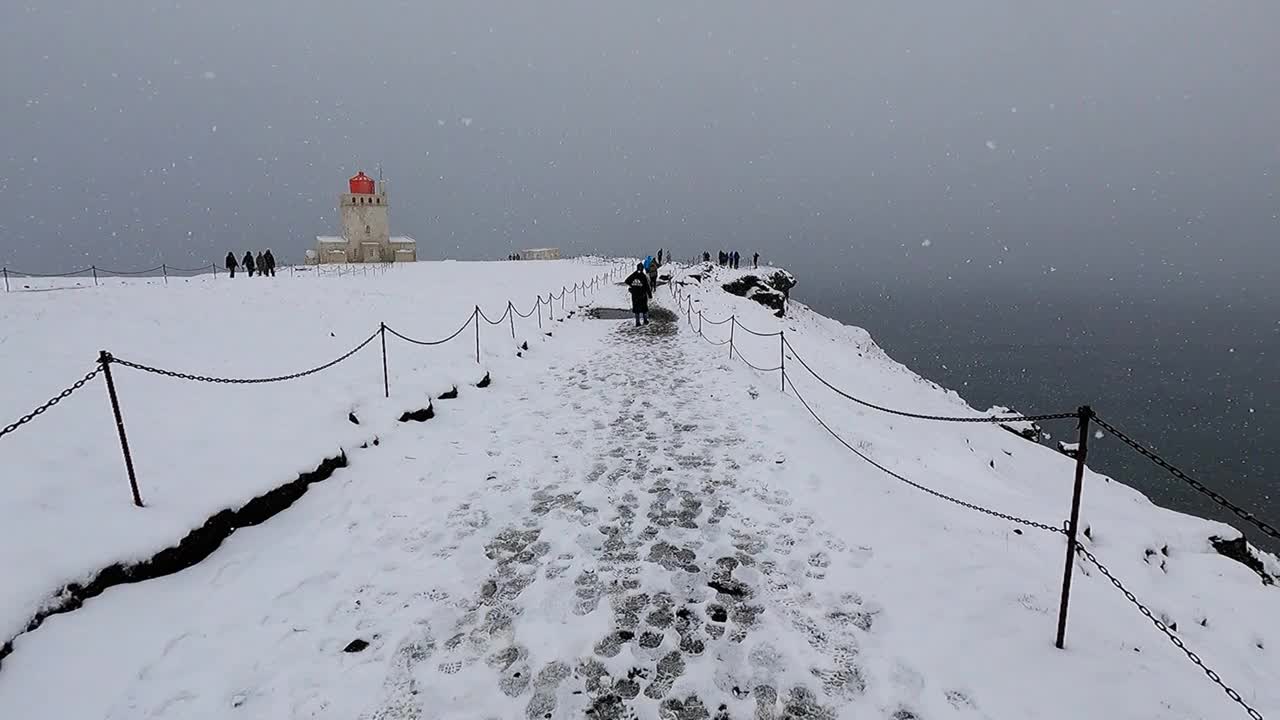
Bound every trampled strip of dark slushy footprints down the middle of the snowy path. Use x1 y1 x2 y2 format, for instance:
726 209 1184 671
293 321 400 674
365 307 919 720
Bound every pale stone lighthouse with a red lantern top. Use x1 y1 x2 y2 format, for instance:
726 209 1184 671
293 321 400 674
316 172 417 263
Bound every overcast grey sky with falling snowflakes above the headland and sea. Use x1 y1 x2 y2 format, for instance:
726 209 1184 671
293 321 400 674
0 0 1280 292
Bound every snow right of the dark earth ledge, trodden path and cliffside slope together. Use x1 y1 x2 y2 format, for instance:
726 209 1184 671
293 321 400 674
0 265 1280 720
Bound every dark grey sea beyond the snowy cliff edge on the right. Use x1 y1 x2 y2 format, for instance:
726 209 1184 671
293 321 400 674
794 273 1280 552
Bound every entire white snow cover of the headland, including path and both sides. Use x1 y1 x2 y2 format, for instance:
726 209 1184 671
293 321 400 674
0 261 1280 720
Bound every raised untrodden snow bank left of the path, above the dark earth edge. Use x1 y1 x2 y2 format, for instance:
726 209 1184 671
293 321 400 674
0 260 612 643
